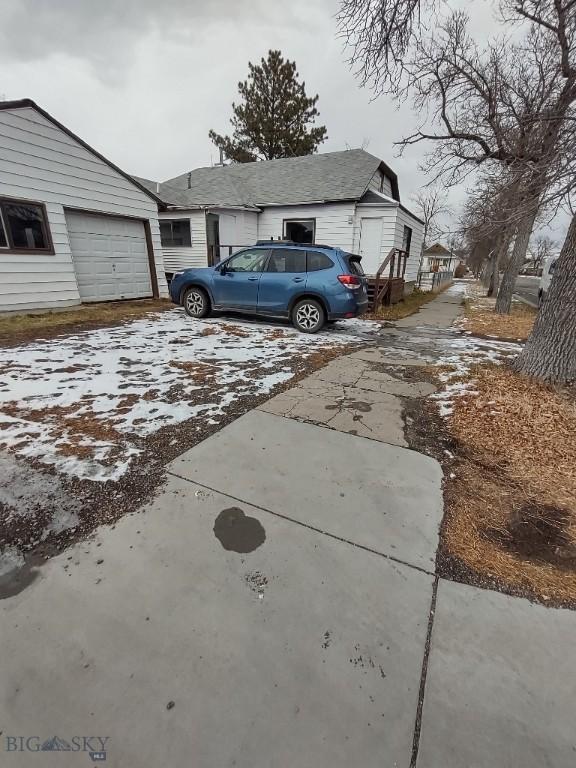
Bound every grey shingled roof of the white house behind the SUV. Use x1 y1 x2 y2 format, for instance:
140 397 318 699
139 149 400 208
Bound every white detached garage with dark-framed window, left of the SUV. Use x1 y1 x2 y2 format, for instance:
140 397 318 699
0 99 167 311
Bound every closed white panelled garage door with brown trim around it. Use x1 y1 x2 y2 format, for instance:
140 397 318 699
66 211 152 301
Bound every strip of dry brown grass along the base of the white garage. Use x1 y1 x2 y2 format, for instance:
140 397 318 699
0 299 174 341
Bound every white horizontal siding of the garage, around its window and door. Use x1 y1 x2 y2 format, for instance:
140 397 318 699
0 107 167 311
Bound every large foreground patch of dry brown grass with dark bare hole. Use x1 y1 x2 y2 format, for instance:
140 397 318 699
443 366 576 603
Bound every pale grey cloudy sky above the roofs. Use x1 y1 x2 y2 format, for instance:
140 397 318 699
0 0 568 242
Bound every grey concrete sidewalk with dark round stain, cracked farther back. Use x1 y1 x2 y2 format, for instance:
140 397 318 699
0 284 576 768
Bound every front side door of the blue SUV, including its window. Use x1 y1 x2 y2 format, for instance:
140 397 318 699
212 248 269 311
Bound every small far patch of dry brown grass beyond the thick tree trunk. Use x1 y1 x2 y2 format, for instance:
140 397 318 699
460 298 536 341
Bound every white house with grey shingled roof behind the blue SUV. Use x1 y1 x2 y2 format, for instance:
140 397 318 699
135 149 423 283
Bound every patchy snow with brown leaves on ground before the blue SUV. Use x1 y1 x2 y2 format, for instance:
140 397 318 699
0 309 380 481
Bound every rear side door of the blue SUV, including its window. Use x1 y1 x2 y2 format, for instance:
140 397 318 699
258 248 306 316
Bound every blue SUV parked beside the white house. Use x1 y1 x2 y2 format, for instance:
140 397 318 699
170 240 368 333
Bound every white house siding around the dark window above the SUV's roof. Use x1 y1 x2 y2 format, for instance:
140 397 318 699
258 203 355 251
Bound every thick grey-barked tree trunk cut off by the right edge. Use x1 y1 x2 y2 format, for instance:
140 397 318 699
514 215 576 384
